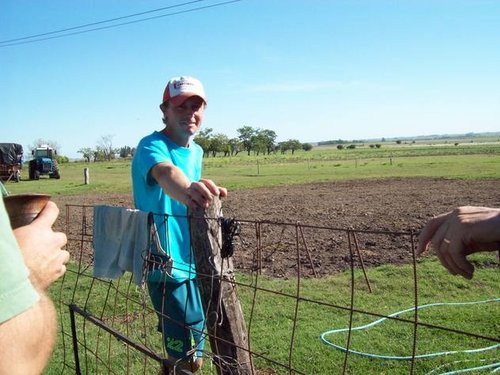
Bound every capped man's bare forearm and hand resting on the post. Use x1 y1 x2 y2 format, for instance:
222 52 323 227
150 162 227 208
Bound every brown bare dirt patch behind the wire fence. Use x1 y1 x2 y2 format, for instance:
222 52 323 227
53 178 500 277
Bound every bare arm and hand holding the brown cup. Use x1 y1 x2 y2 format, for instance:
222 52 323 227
0 202 69 375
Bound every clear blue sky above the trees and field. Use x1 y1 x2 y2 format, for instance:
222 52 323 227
0 0 500 157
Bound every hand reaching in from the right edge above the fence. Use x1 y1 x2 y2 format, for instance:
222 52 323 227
417 206 500 279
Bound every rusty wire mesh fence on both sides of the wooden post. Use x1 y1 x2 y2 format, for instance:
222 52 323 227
51 205 500 375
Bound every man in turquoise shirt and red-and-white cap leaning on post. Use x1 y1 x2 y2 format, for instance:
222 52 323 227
132 77 227 371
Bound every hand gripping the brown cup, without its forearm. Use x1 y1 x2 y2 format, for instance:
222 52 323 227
14 201 69 290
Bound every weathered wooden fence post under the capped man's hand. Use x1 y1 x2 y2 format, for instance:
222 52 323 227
189 198 253 375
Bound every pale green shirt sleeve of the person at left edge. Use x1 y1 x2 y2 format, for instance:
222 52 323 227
0 199 40 324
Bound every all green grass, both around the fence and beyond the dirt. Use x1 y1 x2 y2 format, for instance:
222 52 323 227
2 142 500 375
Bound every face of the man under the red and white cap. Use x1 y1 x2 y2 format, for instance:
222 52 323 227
164 96 205 137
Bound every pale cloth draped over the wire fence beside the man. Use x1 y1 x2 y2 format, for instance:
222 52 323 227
92 205 151 285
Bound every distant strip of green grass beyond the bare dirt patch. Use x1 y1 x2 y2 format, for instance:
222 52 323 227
6 142 500 195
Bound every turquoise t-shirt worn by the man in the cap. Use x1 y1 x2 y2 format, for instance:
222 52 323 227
132 131 203 281
